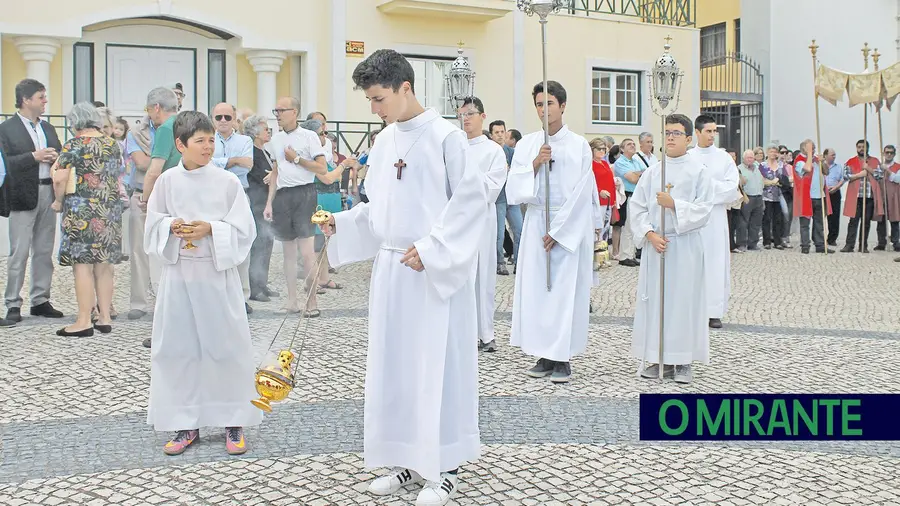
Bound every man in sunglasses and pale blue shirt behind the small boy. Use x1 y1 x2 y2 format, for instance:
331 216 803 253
212 102 253 314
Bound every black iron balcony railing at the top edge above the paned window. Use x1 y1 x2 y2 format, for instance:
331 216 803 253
563 0 697 26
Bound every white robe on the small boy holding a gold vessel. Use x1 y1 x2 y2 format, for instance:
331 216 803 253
144 164 262 431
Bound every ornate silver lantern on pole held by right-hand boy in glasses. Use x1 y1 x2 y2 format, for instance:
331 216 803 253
641 37 691 381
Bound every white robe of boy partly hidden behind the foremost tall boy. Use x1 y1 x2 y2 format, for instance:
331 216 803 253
466 135 509 343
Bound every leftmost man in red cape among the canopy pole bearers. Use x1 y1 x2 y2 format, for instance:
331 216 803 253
794 139 834 253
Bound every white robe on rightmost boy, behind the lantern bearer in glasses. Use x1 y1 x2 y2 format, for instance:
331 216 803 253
690 146 741 319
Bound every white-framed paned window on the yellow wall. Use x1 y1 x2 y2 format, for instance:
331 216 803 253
591 69 641 125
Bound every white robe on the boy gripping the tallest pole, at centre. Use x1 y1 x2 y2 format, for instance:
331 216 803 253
506 126 599 362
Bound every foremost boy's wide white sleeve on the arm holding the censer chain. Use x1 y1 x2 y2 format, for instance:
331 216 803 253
328 203 381 267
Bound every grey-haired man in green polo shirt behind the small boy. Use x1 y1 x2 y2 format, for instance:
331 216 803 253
136 87 181 348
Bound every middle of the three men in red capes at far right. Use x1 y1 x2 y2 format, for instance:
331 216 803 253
841 139 884 253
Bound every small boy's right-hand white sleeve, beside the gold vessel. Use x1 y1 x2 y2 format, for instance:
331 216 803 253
208 177 256 272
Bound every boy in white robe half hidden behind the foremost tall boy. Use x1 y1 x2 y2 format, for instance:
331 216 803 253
458 97 509 353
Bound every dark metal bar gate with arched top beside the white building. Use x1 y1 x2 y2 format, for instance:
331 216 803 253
700 53 763 154
